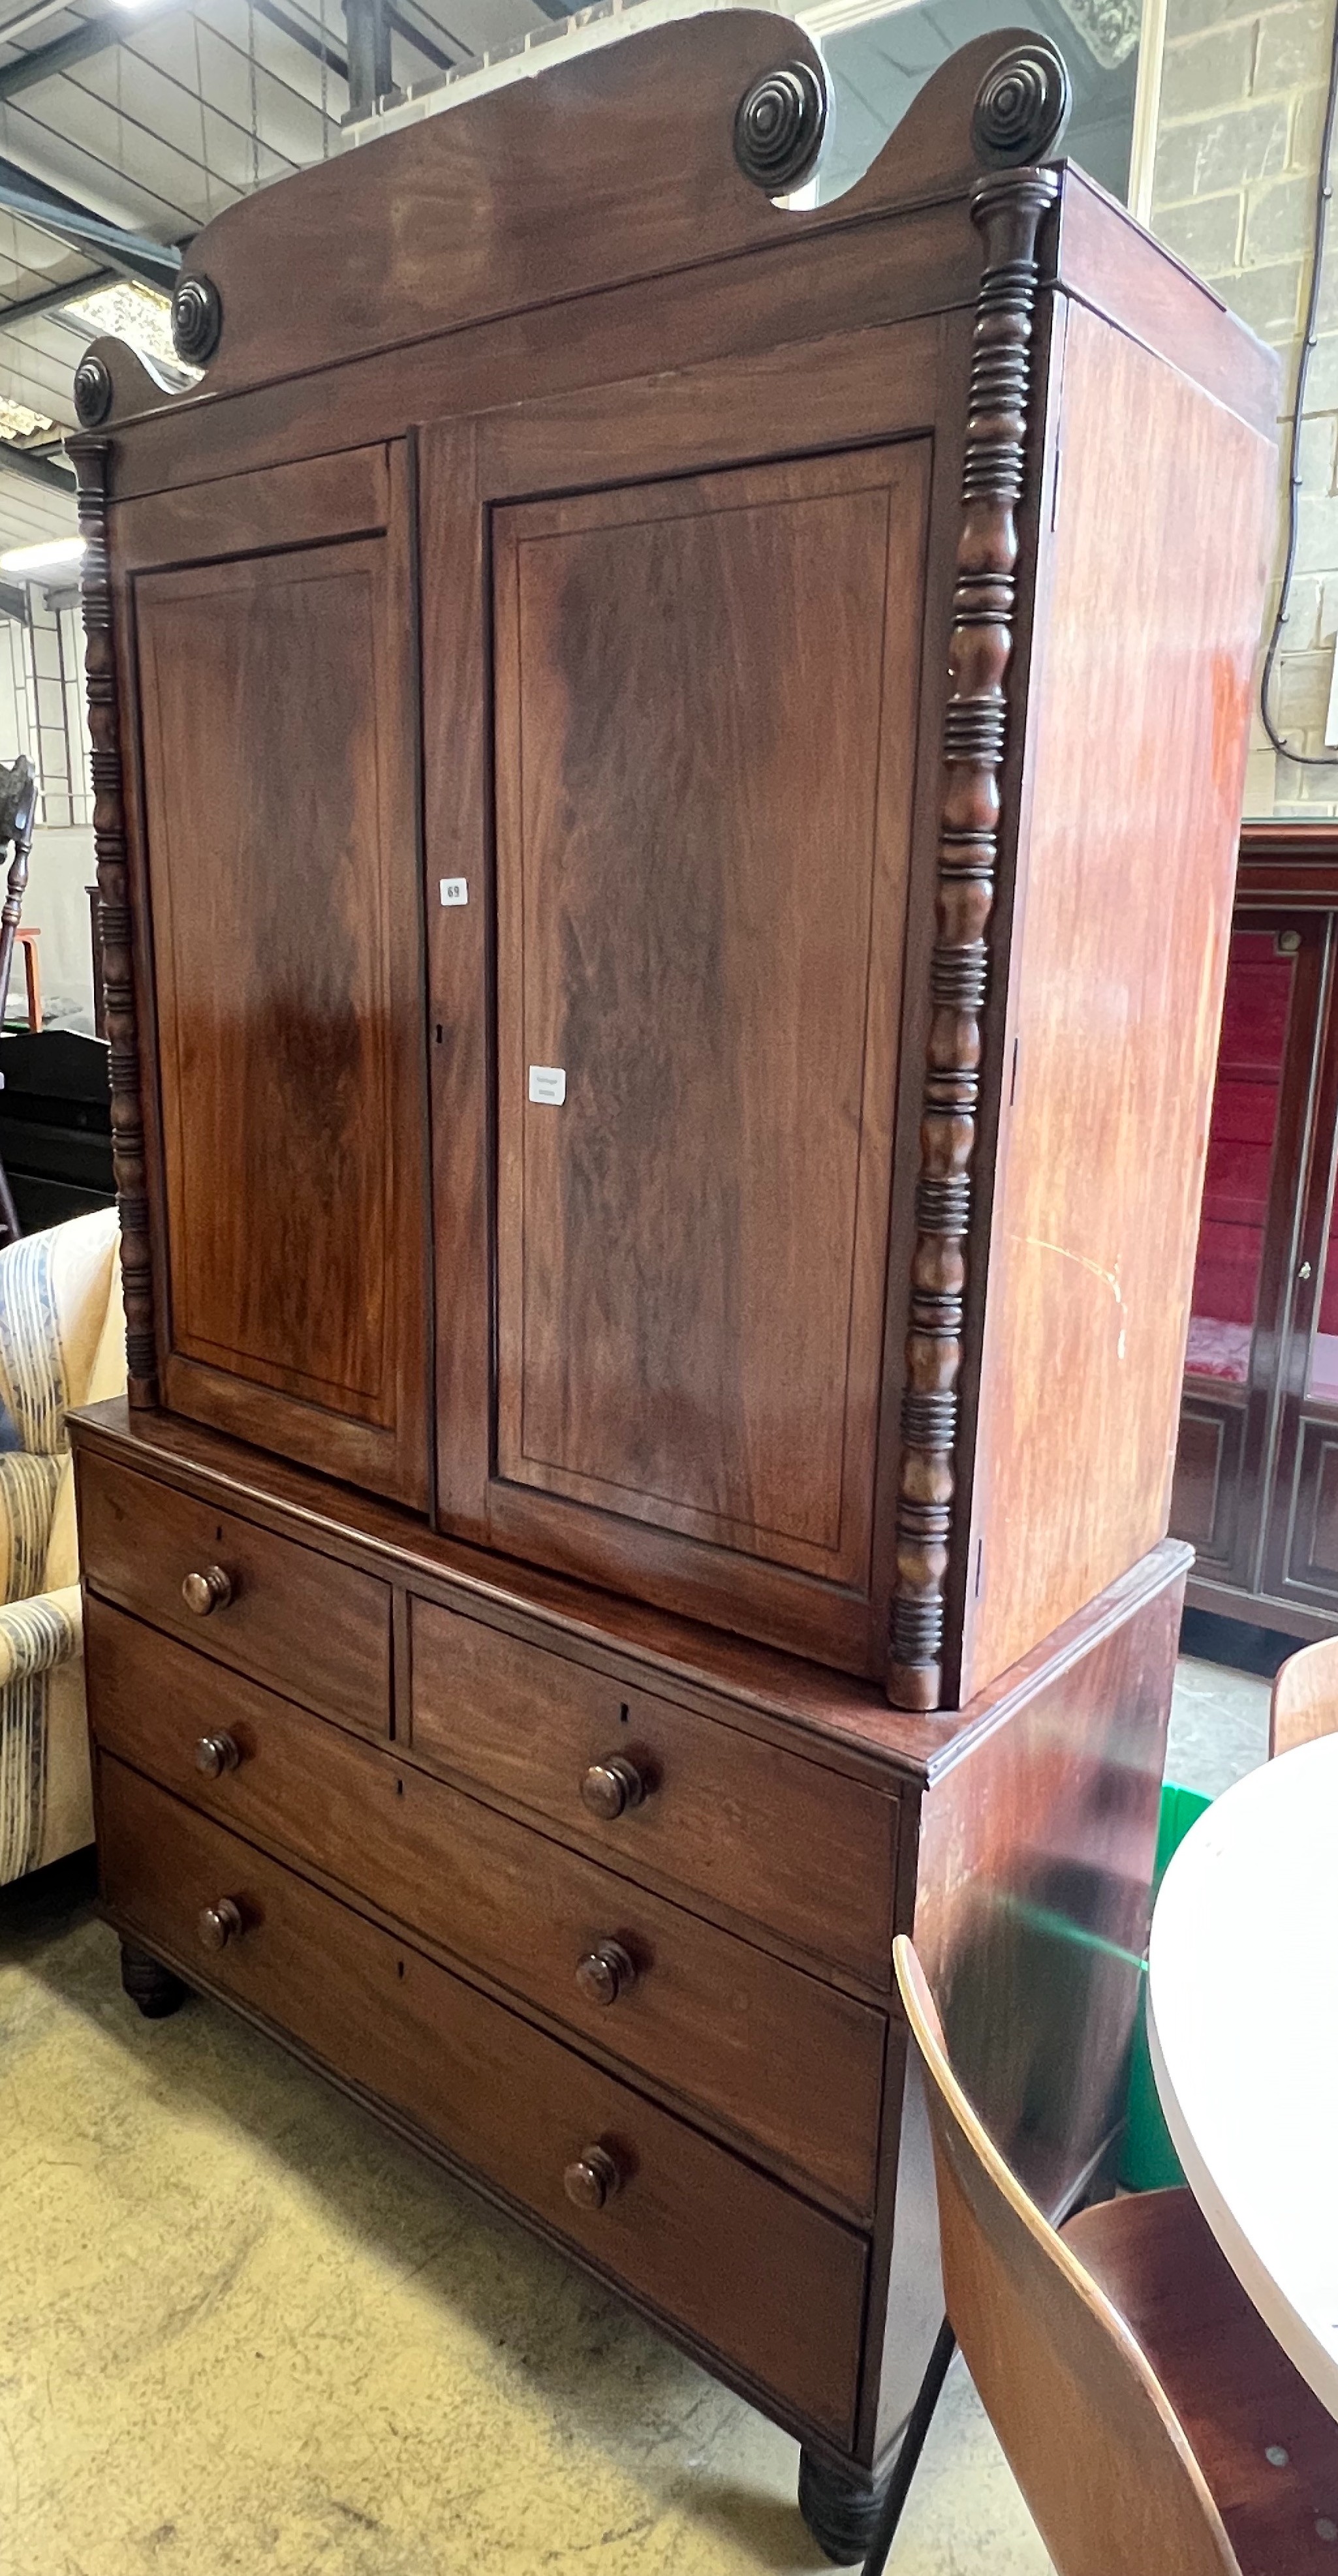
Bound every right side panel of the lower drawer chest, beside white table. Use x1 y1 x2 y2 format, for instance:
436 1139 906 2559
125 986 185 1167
915 1543 1189 2210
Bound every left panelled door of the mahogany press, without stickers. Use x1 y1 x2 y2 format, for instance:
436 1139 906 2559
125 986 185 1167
124 448 428 1505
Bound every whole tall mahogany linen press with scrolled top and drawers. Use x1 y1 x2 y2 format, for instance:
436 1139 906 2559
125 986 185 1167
72 25 1276 2558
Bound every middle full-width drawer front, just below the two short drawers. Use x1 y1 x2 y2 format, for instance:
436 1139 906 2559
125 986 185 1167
85 1600 884 2218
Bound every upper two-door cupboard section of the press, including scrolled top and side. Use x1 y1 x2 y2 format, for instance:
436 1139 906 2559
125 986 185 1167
72 25 1276 1710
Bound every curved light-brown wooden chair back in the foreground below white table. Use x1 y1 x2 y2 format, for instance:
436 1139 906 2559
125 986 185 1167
895 1940 1240 2576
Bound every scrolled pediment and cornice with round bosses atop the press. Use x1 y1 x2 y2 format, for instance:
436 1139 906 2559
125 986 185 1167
75 8 1276 448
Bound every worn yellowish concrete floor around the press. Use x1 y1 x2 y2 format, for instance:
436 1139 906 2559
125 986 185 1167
0 1664 1268 2576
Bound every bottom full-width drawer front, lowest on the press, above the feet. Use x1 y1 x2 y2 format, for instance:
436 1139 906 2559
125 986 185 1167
101 1755 866 2442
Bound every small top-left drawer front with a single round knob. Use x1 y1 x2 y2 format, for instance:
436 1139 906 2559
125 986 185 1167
80 1453 389 1736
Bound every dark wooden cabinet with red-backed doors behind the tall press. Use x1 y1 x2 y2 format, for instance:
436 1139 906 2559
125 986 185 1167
1170 821 1338 1638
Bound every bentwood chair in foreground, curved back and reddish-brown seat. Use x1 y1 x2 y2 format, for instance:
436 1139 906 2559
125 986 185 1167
866 1940 1338 2576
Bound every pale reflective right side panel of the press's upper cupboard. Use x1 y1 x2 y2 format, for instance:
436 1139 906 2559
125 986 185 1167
961 307 1273 1700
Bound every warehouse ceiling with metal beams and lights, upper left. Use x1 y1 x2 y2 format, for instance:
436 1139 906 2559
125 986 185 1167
0 0 554 551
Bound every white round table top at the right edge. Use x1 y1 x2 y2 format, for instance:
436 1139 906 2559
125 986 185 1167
1147 1736 1338 2416
